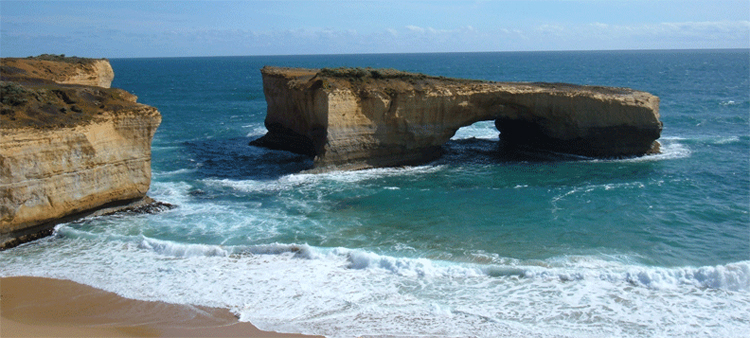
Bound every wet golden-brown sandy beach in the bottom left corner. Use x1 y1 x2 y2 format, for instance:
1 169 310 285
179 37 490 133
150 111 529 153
0 277 321 338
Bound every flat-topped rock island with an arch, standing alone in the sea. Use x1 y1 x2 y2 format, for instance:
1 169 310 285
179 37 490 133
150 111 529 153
251 67 662 170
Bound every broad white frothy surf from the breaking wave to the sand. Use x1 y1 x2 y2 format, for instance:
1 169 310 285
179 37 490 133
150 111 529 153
0 232 750 337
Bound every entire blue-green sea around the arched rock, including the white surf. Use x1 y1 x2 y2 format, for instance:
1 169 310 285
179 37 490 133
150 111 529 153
0 50 750 337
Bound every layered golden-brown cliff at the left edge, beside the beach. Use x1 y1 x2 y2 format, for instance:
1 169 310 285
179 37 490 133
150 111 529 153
0 54 161 248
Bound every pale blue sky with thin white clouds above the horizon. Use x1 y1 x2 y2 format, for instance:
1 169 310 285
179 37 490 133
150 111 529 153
0 0 750 58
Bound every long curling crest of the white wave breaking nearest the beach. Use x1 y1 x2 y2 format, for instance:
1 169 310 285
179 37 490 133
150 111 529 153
73 232 750 291
